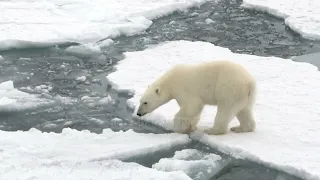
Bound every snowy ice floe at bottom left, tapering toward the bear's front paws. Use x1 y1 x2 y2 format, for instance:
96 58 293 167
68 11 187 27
0 128 191 180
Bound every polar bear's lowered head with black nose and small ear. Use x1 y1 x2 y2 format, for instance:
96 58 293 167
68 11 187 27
137 84 170 116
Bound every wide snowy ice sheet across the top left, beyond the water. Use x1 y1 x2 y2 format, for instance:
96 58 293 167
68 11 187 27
0 0 207 50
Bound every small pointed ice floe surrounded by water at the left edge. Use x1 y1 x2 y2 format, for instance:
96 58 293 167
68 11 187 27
0 81 54 112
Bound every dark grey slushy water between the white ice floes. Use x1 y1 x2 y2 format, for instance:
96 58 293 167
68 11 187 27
0 1 320 180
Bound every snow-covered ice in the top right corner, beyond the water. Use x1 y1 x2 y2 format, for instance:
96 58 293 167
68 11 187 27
241 0 320 39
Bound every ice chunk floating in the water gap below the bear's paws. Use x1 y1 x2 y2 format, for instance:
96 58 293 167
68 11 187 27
152 149 229 180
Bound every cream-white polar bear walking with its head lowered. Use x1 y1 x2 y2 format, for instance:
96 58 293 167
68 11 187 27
137 60 256 135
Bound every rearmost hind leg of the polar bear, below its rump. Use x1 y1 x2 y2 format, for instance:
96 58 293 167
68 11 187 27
231 108 256 133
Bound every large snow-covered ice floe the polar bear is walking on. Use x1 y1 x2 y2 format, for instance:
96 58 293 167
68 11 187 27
107 41 320 179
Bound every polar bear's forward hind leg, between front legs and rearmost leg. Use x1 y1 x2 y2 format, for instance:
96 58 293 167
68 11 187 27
204 106 234 135
